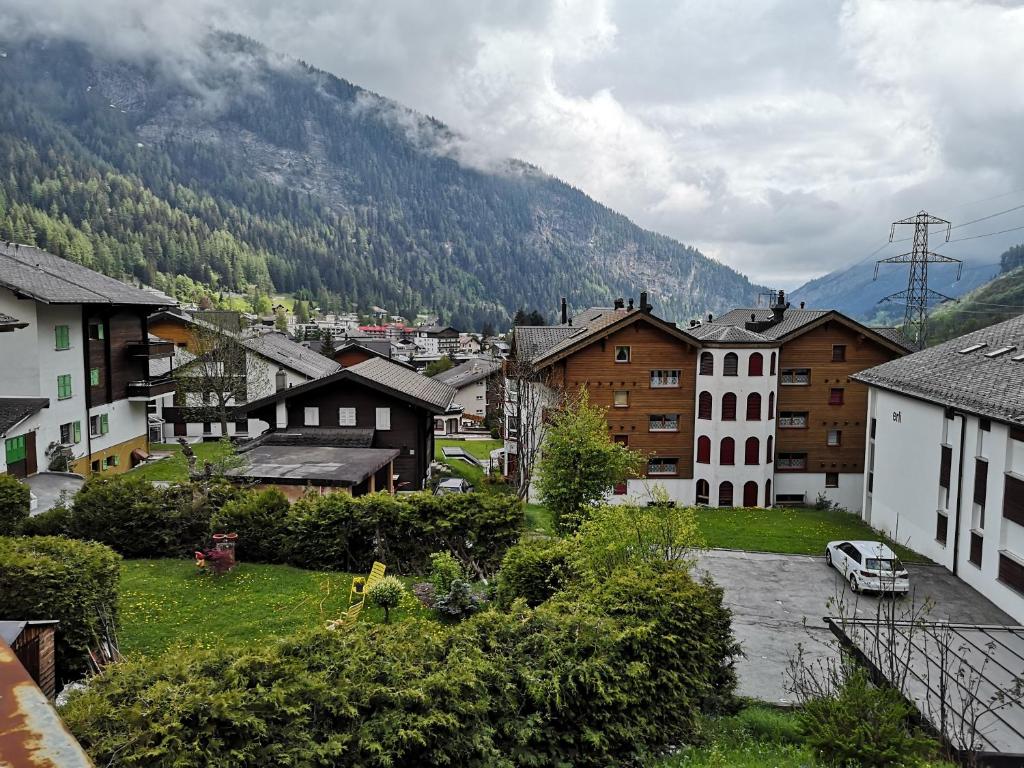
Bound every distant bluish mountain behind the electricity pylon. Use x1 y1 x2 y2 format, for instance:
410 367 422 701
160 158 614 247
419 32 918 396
790 253 999 324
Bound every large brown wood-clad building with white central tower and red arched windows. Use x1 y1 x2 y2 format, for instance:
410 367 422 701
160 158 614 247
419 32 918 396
505 293 908 510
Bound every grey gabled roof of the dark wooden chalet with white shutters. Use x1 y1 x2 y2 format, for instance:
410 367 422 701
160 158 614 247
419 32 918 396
234 357 457 414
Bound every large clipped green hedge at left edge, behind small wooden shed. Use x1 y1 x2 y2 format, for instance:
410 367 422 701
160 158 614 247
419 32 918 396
0 537 121 681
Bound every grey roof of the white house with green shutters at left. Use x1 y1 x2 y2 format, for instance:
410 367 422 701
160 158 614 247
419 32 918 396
0 243 177 306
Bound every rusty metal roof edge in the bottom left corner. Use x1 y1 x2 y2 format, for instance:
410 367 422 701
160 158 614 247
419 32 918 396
0 640 93 768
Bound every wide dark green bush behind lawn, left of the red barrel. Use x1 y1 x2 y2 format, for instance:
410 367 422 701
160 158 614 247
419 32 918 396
69 476 210 557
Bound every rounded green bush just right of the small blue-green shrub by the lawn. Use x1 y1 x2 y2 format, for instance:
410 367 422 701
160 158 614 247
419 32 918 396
498 538 572 608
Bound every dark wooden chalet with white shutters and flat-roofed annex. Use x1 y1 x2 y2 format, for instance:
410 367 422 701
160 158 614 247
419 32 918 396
233 357 456 498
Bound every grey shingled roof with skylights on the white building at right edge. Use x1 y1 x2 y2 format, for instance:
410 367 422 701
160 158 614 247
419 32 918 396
852 314 1024 424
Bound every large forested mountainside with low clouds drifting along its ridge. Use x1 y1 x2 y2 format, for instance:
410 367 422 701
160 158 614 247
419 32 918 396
0 33 761 328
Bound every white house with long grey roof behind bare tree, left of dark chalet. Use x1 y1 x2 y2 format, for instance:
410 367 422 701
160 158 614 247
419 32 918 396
150 311 341 441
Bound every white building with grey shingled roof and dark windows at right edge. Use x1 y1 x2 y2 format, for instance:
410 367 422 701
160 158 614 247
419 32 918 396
852 315 1024 623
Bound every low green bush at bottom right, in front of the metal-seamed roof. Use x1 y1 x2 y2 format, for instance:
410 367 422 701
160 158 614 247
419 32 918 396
800 667 931 768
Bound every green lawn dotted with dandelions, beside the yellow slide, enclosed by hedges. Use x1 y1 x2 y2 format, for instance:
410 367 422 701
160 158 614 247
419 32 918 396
118 560 430 654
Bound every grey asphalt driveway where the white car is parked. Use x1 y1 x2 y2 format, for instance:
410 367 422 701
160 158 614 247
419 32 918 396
696 550 1016 703
